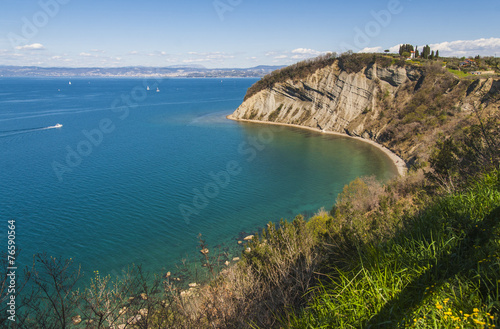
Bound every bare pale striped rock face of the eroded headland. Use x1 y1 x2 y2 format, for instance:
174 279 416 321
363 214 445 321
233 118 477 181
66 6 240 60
233 64 420 133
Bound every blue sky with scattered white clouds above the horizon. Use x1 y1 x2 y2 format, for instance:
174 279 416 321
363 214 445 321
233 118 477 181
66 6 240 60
0 0 500 68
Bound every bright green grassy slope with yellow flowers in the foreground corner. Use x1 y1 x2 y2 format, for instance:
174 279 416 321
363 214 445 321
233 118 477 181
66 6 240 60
283 170 500 328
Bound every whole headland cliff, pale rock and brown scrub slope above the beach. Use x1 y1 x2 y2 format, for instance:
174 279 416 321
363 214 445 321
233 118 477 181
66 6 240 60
230 60 500 165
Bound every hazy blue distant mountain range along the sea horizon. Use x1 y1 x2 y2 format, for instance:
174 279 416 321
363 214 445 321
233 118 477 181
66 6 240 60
0 65 283 78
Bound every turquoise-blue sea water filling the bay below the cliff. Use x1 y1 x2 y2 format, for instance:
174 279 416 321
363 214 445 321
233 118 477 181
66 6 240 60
0 78 396 280
